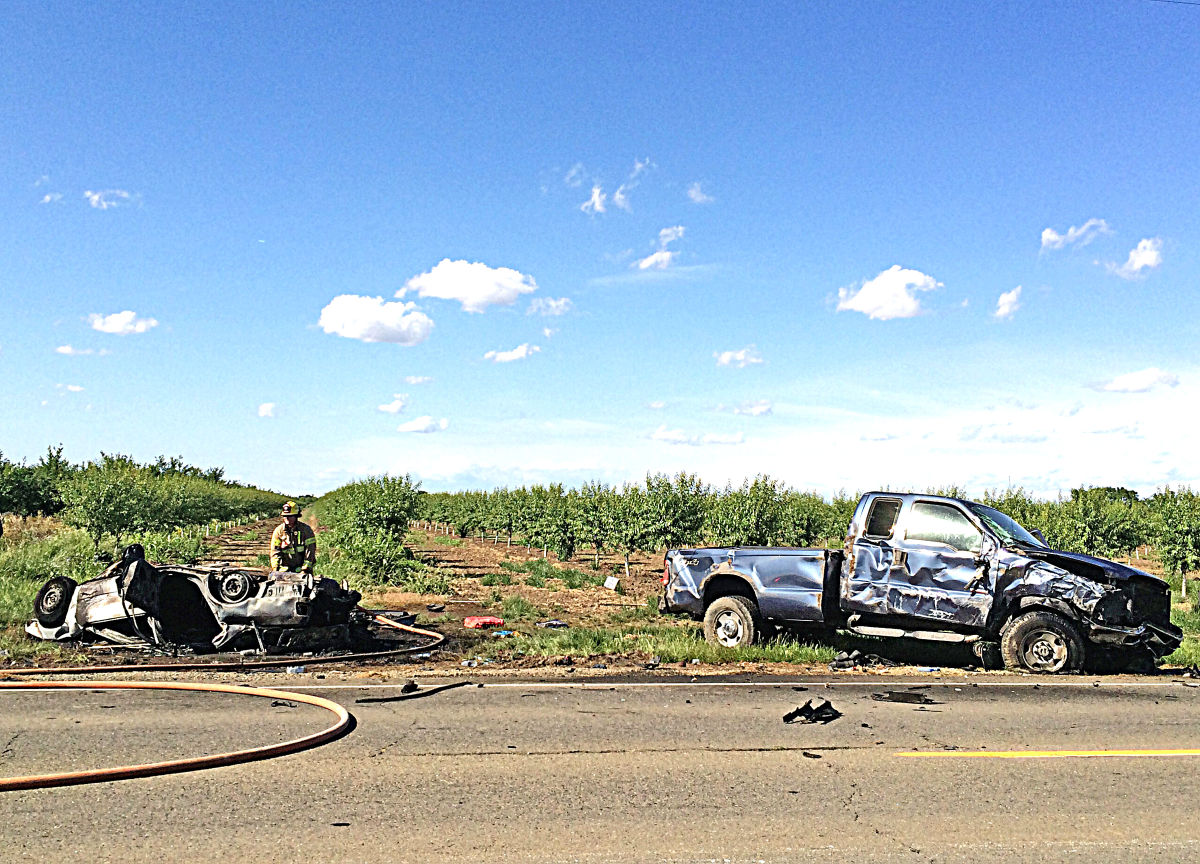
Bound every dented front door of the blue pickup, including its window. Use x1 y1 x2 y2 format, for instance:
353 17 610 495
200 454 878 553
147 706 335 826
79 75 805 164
888 500 996 628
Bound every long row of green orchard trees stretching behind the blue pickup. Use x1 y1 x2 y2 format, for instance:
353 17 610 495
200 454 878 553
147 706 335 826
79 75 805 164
400 474 1200 572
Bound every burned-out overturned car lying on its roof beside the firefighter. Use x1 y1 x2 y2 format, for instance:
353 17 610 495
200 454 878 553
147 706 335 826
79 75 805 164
25 545 361 653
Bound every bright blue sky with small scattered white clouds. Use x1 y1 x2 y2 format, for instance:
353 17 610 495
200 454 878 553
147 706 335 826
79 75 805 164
0 0 1200 496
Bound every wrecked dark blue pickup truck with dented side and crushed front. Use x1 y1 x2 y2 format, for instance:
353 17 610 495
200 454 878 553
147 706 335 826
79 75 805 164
660 492 1183 672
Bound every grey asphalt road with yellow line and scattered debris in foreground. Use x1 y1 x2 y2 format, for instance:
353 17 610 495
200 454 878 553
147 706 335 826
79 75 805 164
0 678 1200 864
